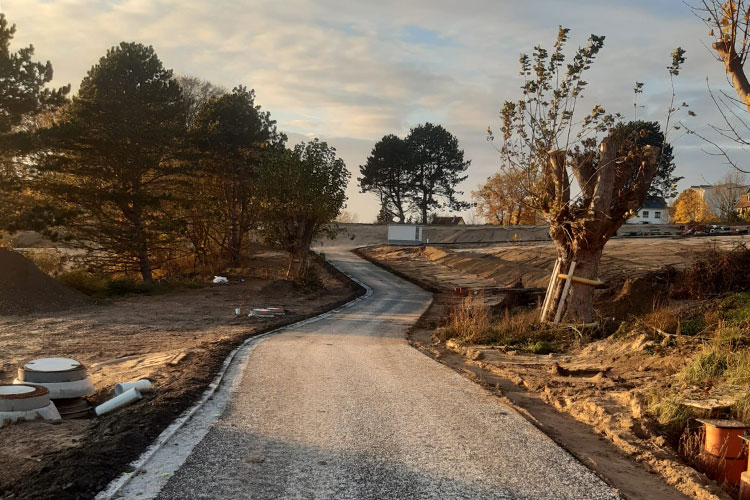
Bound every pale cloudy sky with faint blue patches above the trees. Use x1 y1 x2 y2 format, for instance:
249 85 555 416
0 0 748 222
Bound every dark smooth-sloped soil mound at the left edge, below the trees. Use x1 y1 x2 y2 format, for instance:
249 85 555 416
0 248 87 315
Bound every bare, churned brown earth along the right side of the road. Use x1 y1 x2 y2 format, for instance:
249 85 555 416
358 237 747 499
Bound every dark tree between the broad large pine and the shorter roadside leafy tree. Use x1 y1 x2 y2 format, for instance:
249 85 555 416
189 86 285 266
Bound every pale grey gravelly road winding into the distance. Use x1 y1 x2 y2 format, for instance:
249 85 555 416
154 249 618 499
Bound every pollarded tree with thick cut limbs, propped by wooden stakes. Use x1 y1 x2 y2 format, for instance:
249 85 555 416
490 27 684 323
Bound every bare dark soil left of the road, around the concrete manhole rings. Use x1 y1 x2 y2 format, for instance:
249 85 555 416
0 250 362 500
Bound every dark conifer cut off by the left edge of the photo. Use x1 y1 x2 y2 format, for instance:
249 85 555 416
0 14 70 229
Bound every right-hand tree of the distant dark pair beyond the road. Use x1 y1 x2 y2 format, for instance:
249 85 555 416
406 123 471 224
